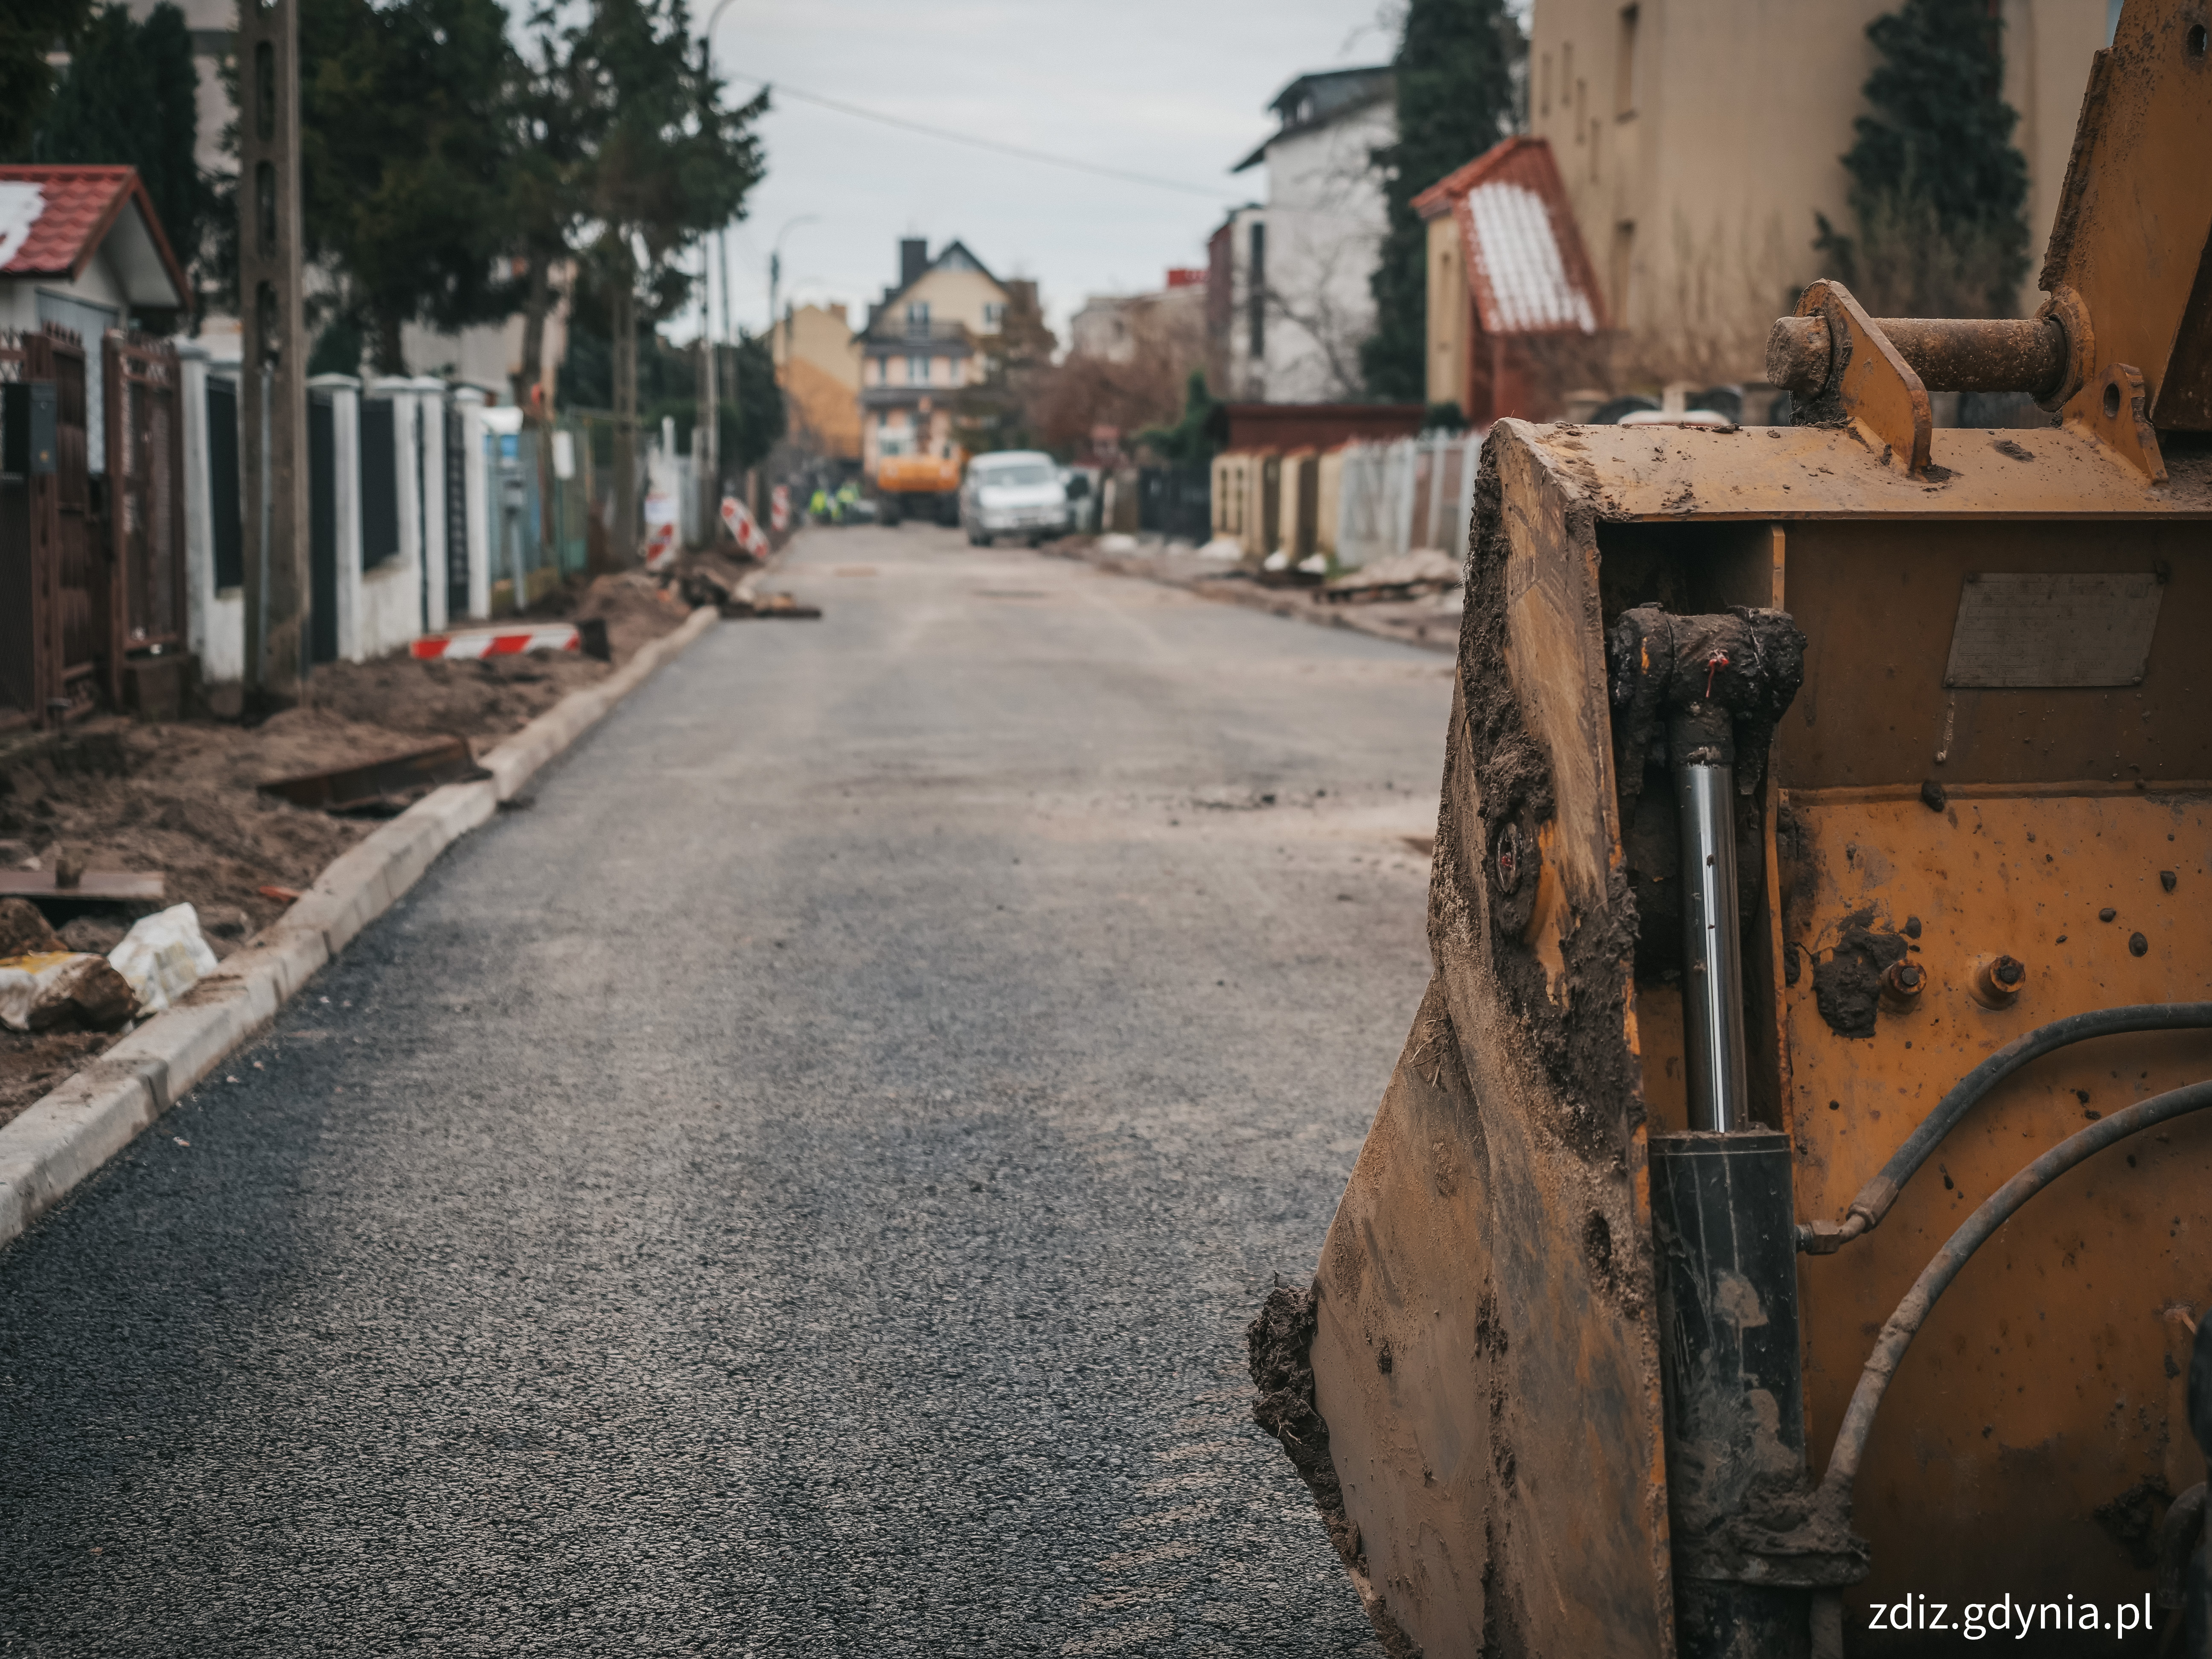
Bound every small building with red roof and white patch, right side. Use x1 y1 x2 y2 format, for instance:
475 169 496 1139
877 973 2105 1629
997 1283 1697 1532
1414 137 1608 427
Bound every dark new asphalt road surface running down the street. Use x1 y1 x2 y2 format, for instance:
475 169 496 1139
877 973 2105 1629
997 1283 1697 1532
0 527 1451 1659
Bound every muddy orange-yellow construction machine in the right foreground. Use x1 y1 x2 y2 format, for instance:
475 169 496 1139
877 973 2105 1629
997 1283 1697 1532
1250 0 2212 1659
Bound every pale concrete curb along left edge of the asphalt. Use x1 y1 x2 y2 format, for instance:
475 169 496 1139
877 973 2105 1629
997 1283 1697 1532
0 608 719 1246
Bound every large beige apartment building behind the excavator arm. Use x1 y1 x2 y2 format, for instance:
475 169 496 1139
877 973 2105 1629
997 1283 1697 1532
1528 0 2119 385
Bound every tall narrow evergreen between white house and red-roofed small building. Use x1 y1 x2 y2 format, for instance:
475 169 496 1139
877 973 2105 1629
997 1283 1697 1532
1360 0 1526 402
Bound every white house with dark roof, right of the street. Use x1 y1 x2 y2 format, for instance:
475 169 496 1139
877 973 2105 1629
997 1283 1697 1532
1205 67 1398 402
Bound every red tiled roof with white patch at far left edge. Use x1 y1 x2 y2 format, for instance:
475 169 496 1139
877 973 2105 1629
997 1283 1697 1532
0 166 192 310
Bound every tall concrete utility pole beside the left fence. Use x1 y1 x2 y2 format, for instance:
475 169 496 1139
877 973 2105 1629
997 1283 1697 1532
239 0 310 706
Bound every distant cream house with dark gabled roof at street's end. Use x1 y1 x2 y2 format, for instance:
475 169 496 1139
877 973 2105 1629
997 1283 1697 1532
858 237 1009 478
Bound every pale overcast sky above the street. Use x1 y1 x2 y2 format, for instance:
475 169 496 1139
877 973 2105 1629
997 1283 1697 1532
690 0 1396 338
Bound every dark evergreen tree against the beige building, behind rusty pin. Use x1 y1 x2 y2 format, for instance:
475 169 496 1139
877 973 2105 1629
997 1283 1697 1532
1814 0 2029 316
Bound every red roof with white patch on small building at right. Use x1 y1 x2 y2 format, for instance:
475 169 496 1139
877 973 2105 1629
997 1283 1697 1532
1414 137 1610 334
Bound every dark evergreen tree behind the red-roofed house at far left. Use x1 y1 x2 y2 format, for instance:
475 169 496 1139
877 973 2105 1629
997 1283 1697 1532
31 0 215 303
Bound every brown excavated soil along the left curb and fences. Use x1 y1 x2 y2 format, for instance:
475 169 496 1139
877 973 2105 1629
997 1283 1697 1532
0 573 688 1123
